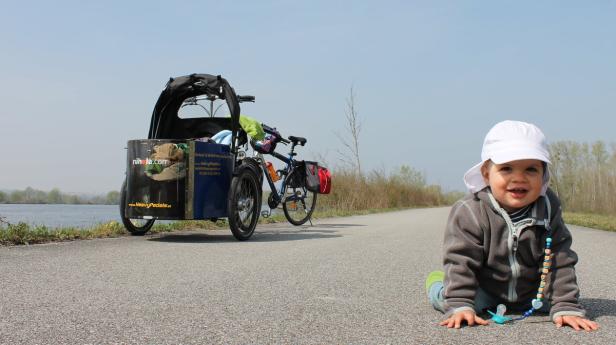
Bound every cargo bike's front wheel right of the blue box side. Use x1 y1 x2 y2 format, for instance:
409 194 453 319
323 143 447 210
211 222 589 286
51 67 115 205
228 166 261 241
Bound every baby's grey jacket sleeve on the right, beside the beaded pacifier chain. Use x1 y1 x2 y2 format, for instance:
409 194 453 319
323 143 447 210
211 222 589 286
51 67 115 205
546 194 585 319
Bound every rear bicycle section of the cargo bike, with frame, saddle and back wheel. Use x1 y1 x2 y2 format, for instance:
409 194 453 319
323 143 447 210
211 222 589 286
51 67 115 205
250 124 317 226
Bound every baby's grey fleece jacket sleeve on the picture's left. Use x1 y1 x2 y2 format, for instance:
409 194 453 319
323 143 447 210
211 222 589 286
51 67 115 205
443 200 484 316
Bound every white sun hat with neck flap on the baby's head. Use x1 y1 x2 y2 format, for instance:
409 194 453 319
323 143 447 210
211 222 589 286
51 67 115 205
464 120 550 195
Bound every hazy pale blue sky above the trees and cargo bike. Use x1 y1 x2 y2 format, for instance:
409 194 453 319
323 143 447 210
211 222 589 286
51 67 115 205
0 0 616 193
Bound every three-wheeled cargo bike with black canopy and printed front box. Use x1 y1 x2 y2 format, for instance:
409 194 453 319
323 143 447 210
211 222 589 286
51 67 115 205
120 74 318 240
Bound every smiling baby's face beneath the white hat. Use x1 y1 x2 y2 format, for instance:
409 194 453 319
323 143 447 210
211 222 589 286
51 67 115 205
481 159 543 212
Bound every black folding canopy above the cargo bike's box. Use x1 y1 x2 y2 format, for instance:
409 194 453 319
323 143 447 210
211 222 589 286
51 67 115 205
148 74 240 150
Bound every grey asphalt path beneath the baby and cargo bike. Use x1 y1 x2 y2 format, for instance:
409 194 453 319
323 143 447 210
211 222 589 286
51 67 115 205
0 208 616 344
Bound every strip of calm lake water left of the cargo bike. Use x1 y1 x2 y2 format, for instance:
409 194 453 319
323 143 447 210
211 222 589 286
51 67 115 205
0 204 121 228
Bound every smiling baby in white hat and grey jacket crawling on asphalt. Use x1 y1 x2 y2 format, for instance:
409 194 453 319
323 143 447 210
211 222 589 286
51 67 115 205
426 121 599 331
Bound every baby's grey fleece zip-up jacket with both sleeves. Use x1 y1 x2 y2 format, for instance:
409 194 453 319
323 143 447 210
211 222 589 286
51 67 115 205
443 188 584 319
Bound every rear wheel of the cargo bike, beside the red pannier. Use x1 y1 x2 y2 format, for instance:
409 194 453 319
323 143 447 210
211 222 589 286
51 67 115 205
282 172 317 225
